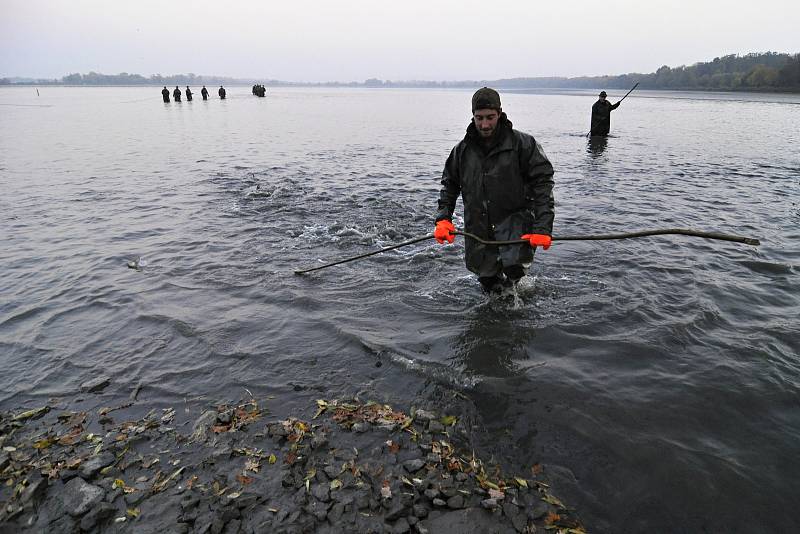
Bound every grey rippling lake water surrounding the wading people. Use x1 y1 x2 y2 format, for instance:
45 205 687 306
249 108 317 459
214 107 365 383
0 87 800 532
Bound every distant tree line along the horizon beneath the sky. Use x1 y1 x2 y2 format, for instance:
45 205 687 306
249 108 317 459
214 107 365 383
0 52 800 92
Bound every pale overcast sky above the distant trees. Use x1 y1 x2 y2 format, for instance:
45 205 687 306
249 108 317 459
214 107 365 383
0 0 800 81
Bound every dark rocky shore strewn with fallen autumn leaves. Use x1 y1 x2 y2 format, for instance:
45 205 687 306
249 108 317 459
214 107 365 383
0 380 586 534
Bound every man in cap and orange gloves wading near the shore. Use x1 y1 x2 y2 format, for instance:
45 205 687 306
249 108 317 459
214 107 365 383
434 87 555 293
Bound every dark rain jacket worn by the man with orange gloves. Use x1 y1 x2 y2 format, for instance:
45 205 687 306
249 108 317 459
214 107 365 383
436 113 555 276
